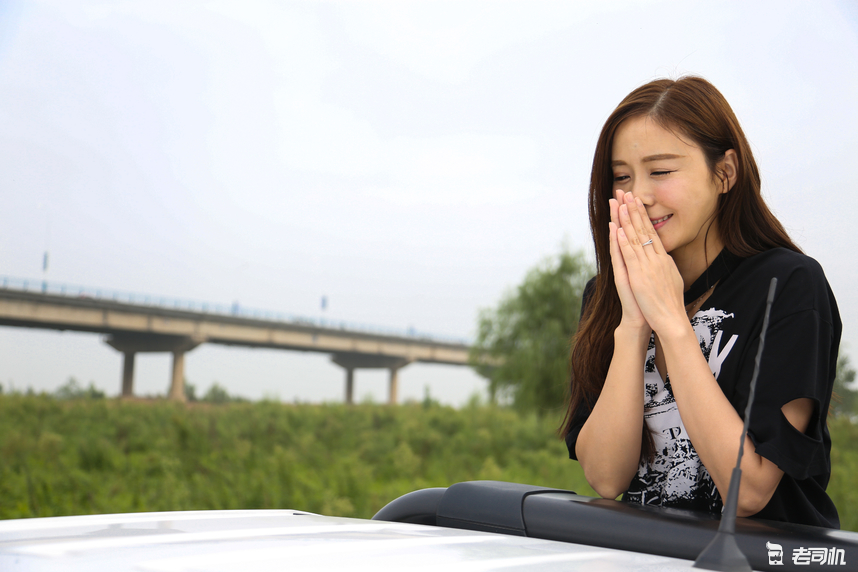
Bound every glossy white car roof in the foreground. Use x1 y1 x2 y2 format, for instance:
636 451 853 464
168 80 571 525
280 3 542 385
0 510 704 572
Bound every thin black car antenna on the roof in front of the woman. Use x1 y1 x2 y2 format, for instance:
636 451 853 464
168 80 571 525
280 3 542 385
694 278 778 572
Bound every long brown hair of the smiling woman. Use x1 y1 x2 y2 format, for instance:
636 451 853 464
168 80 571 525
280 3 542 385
561 76 801 457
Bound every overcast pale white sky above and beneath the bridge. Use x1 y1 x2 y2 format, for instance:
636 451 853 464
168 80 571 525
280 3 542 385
0 0 858 404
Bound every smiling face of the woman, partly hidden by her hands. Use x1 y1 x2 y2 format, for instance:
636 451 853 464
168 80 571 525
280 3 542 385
611 116 735 274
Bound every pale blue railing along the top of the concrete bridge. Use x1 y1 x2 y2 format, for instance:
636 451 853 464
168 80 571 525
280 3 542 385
0 276 470 345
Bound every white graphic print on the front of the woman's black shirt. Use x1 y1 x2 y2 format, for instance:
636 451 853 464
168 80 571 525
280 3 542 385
627 308 738 512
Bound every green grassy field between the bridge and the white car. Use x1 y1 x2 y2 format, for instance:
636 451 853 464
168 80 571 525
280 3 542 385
0 395 858 530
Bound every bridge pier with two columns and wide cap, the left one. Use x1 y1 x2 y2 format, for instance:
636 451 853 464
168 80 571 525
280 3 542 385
105 333 204 401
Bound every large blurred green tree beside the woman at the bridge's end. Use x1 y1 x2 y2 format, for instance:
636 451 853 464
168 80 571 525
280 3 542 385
470 248 595 413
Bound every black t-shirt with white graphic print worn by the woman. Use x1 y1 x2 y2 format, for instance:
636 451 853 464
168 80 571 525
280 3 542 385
566 248 841 528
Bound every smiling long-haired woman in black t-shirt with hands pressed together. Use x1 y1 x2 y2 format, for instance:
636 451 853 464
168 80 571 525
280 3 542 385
564 77 841 528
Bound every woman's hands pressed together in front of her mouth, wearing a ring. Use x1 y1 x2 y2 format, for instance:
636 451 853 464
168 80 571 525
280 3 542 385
609 190 687 333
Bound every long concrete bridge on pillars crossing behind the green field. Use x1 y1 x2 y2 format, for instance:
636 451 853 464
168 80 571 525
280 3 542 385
0 278 470 403
